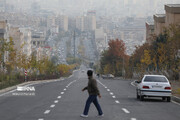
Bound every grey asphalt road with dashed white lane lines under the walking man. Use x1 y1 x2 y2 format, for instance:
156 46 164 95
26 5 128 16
0 70 180 120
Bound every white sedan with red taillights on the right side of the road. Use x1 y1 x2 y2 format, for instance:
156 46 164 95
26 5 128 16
135 75 171 102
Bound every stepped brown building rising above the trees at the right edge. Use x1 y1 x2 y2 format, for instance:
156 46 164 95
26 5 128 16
146 4 180 43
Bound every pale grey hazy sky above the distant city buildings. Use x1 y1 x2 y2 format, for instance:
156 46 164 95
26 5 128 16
4 0 180 16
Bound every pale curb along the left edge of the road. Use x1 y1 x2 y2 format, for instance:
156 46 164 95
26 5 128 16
0 78 64 95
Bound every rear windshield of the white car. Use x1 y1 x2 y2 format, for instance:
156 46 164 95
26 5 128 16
144 76 168 82
